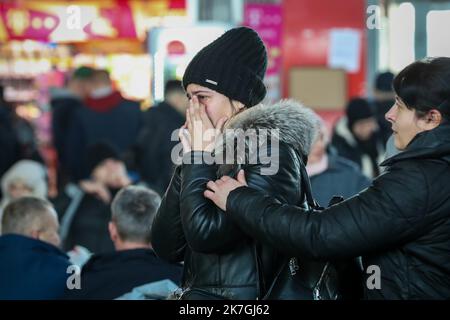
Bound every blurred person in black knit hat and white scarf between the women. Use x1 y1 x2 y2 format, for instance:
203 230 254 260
331 98 385 179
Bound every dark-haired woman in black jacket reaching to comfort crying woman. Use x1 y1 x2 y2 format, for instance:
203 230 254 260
202 57 450 300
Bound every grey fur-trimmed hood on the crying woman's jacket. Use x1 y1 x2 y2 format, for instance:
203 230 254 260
215 100 319 176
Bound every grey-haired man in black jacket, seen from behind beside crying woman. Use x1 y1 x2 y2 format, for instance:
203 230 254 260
68 186 181 299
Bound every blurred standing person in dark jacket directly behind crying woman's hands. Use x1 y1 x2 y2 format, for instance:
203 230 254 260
135 80 189 194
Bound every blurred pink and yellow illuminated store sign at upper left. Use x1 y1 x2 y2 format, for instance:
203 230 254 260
0 0 186 42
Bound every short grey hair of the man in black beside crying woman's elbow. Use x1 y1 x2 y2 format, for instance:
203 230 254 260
111 186 161 243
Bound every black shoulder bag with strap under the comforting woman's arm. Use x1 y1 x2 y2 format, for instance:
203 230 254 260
257 164 342 300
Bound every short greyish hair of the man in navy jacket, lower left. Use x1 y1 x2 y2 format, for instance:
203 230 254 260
1 197 56 236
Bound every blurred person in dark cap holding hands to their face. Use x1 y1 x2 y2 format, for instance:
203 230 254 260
54 141 133 253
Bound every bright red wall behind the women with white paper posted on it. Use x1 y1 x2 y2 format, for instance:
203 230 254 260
282 0 367 121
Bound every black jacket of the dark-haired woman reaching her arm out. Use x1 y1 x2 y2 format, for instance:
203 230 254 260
227 125 450 299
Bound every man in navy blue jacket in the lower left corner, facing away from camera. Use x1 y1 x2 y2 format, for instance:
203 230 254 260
0 197 69 300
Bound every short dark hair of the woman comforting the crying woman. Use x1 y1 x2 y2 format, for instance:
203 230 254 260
394 57 450 120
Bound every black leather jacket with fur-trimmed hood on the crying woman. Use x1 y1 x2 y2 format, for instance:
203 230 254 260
152 103 314 299
